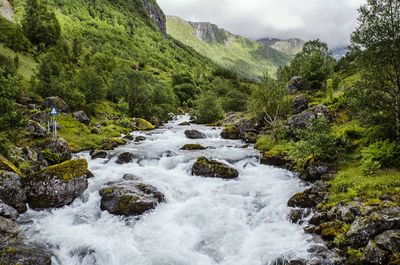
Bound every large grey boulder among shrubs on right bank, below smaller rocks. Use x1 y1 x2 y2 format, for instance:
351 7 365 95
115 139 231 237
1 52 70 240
286 105 332 130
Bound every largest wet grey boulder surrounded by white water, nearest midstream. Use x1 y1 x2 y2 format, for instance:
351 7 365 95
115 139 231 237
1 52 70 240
100 175 164 216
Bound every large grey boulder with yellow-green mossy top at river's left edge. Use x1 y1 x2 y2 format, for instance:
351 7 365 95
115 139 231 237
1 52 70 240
23 159 93 209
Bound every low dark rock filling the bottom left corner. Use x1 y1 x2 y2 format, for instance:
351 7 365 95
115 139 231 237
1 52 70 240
0 244 52 265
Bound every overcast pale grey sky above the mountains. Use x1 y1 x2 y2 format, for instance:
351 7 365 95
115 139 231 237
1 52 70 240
157 0 365 49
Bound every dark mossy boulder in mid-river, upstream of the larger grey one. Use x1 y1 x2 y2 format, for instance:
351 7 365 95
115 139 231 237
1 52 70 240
192 157 239 179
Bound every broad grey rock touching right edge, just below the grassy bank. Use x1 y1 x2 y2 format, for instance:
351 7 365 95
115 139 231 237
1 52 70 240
346 206 400 247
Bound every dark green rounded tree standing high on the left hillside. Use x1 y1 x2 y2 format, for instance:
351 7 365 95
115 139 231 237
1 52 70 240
22 0 61 47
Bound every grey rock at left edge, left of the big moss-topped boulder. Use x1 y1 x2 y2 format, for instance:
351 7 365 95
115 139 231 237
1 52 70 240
0 171 27 213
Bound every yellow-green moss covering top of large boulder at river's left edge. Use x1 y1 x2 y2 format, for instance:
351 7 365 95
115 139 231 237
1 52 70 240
29 159 88 183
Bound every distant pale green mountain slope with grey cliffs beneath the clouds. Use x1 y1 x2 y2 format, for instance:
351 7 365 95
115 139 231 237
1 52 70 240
167 16 292 77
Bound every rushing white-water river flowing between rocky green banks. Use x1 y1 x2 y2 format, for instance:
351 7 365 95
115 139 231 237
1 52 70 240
20 116 311 265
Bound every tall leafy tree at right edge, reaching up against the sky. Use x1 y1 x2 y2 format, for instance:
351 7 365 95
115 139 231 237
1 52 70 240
351 0 400 140
